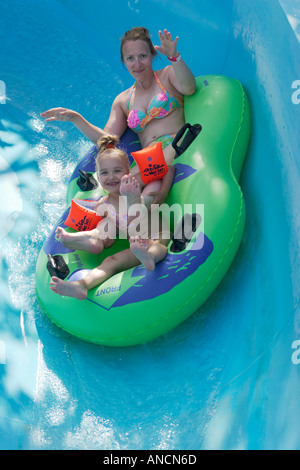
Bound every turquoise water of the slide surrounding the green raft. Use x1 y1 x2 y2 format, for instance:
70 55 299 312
0 0 300 449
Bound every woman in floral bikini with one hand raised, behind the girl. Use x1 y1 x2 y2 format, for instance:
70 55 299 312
41 27 196 203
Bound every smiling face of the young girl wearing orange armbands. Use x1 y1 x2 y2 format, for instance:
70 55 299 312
97 155 129 194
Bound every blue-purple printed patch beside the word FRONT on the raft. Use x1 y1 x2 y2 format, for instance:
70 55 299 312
112 232 214 307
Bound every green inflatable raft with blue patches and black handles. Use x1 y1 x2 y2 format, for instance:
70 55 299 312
36 75 250 347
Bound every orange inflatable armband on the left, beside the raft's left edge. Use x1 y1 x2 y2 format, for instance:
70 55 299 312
65 199 102 232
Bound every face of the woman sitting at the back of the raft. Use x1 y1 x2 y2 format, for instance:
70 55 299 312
122 39 154 80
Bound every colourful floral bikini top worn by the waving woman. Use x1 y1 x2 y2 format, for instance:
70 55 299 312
127 72 183 134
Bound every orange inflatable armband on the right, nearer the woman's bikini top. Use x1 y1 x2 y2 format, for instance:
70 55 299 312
131 142 168 184
